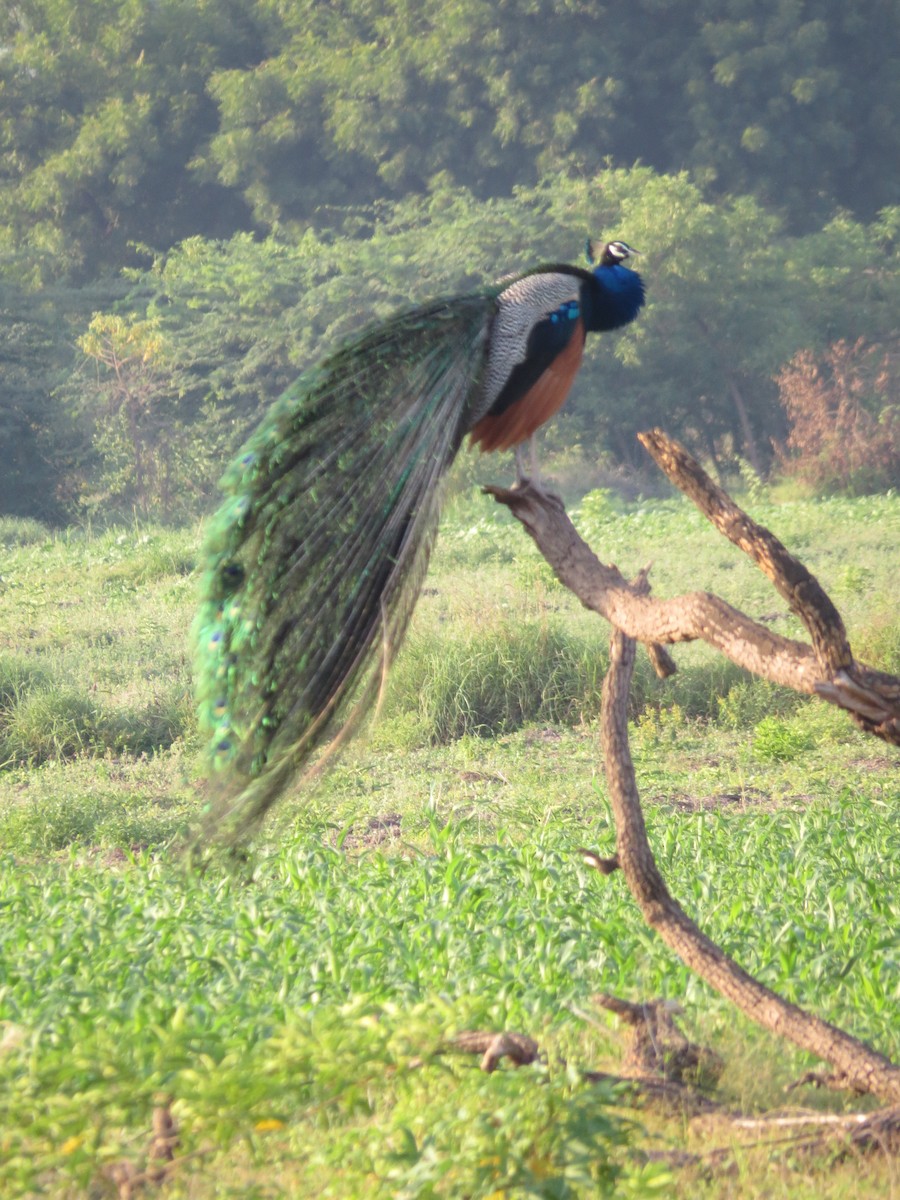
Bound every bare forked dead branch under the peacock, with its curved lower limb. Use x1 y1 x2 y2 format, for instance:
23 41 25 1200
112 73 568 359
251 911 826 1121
487 430 900 1104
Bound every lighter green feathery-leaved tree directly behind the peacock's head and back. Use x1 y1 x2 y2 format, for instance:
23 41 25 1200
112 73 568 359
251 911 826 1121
90 168 898 511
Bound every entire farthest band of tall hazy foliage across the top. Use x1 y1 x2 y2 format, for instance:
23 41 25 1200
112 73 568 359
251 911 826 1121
0 0 900 265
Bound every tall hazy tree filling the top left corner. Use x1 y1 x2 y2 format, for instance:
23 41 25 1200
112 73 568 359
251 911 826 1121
0 0 259 281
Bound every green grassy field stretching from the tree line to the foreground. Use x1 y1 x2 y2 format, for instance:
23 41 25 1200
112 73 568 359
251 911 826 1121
0 482 900 1200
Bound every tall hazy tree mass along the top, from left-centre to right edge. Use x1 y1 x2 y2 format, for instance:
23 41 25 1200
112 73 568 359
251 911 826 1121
205 0 900 232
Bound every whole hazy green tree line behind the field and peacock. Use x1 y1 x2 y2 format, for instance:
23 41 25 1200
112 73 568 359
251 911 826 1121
0 0 900 518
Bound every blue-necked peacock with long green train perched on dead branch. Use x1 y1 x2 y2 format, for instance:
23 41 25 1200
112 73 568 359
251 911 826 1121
193 241 644 841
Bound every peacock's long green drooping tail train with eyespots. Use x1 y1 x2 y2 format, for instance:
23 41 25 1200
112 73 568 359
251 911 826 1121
194 296 491 840
